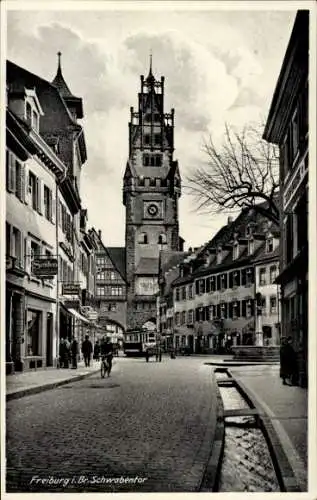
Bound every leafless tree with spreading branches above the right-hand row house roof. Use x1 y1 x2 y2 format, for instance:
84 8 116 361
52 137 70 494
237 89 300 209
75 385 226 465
187 125 279 224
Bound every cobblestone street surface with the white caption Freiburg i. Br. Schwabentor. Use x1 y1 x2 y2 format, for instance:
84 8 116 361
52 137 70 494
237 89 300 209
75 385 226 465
7 358 216 492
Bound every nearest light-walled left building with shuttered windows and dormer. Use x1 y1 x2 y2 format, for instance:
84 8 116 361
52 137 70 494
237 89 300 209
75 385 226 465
6 68 67 372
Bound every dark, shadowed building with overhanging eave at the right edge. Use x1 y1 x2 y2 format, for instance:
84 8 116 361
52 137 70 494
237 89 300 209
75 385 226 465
264 10 309 386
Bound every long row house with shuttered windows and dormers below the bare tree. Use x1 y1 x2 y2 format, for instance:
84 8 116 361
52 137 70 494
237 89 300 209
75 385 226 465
160 209 279 352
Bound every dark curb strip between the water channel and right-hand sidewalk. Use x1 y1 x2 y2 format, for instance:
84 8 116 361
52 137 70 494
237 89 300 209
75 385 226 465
229 372 303 492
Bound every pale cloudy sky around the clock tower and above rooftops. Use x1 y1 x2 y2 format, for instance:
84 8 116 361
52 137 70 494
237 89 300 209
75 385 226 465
7 2 296 248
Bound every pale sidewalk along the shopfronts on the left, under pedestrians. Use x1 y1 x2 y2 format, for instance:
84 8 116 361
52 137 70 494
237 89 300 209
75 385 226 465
6 361 100 401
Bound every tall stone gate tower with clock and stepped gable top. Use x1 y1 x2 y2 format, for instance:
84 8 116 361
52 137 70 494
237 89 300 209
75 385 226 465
123 58 183 329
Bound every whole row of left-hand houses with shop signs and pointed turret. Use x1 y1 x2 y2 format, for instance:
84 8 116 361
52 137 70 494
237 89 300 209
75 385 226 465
6 57 98 372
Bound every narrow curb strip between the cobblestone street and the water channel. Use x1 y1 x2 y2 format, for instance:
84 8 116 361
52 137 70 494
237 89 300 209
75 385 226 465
199 372 225 492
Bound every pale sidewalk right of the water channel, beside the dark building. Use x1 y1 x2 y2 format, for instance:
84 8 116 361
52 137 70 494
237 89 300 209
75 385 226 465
229 365 308 491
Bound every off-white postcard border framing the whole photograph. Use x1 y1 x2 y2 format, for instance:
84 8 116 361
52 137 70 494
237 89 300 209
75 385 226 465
0 0 317 500
